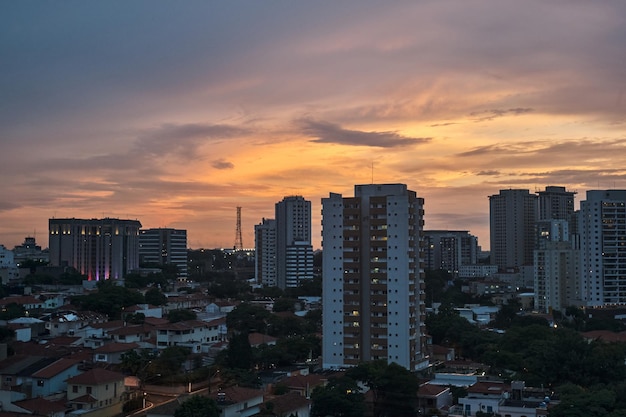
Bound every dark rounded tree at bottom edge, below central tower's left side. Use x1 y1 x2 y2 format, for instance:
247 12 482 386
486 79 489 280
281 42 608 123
311 377 365 417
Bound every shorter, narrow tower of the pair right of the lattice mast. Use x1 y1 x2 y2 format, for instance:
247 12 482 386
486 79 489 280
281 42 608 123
254 219 278 287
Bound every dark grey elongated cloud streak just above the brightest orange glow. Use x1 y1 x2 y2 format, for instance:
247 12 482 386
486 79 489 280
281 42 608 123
298 120 431 148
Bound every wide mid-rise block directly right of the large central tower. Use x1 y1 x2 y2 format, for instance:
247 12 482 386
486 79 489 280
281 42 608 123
424 230 478 276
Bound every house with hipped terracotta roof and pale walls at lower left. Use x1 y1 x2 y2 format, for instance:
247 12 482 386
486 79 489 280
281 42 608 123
67 368 126 417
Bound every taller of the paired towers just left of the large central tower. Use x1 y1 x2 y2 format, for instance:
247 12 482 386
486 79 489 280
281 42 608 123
276 196 313 289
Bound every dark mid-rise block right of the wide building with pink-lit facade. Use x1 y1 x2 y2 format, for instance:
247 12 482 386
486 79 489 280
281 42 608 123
139 227 187 280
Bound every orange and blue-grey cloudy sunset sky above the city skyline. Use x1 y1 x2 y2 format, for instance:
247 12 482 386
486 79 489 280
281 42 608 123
0 0 626 250
